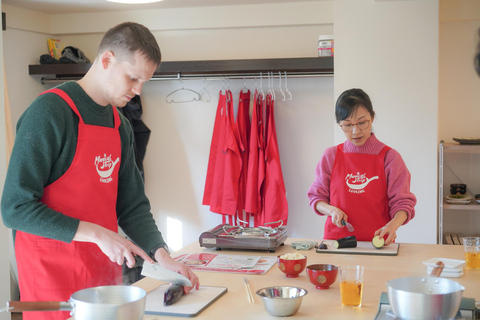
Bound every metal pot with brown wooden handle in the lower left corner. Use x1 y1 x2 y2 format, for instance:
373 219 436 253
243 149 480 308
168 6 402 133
7 286 147 320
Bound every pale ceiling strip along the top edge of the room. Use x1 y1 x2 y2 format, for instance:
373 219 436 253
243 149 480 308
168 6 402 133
1 0 318 14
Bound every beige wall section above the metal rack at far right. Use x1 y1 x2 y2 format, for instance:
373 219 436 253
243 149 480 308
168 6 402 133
438 0 480 141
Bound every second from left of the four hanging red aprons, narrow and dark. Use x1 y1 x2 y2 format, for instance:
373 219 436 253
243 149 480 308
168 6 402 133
235 90 250 221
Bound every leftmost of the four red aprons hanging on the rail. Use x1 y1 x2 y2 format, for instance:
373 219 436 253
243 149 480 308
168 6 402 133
204 91 242 218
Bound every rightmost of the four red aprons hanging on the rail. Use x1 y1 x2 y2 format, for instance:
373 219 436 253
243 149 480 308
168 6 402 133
258 94 288 225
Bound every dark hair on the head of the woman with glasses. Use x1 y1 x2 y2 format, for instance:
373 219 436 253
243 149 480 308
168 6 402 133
335 89 375 123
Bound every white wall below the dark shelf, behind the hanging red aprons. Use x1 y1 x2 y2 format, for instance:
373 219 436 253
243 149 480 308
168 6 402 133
142 78 333 251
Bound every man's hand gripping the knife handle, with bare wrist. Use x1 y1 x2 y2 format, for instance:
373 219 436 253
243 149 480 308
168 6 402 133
73 221 153 268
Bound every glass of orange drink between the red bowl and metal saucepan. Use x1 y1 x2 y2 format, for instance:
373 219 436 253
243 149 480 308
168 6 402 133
339 265 364 307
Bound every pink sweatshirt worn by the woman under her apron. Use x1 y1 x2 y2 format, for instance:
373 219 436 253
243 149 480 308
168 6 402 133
308 133 417 224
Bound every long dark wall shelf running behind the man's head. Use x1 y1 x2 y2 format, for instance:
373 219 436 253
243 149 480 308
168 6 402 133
28 57 333 82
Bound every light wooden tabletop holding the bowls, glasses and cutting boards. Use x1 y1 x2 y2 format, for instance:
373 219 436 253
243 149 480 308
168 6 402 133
134 239 480 320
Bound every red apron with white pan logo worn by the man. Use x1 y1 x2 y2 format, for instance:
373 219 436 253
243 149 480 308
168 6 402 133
15 89 122 320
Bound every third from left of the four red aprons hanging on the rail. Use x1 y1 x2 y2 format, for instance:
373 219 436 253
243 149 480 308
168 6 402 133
245 91 265 226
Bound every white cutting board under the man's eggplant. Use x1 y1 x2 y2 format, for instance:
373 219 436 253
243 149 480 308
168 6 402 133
145 283 227 317
